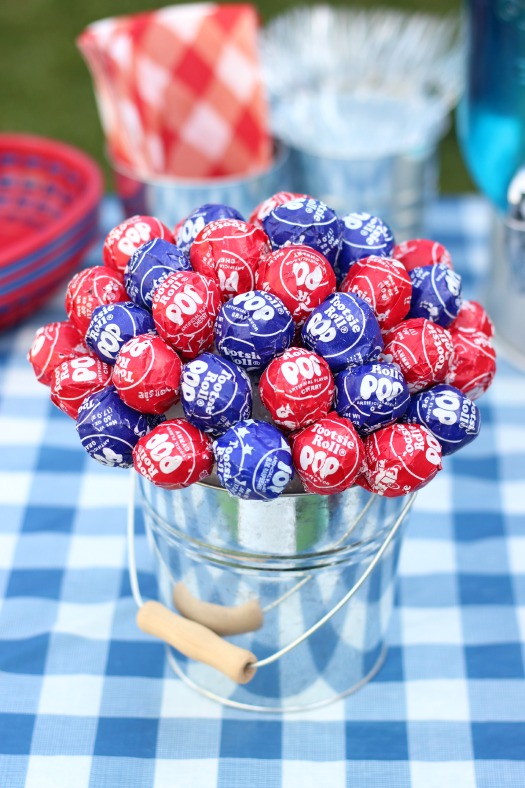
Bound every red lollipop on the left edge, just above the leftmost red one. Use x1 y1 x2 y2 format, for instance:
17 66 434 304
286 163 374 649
66 265 129 335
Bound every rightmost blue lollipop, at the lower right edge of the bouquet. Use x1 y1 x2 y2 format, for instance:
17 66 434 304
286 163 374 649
403 384 481 456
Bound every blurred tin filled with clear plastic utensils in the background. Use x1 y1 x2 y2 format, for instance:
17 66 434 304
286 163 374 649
261 6 462 240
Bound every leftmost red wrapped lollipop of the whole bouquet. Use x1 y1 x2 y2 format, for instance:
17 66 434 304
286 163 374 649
27 320 90 386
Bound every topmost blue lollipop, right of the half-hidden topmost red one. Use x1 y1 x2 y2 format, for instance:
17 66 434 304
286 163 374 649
263 197 342 266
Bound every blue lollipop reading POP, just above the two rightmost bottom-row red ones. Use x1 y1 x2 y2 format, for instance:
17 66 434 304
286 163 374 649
335 363 410 435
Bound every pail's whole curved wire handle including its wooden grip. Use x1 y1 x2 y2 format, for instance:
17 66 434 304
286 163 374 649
127 471 416 684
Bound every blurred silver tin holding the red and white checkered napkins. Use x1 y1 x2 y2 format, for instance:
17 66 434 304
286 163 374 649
110 142 291 227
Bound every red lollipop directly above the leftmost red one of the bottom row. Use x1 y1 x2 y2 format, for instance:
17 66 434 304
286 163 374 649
113 334 182 413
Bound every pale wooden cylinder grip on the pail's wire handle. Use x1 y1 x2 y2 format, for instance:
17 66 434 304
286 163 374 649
137 601 257 684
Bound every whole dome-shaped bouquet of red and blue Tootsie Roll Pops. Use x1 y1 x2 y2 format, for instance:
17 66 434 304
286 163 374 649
29 193 495 501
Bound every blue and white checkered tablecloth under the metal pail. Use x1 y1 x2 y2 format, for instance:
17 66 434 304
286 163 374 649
0 197 525 788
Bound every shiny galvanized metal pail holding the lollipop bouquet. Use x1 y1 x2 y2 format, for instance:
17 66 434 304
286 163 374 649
129 479 414 712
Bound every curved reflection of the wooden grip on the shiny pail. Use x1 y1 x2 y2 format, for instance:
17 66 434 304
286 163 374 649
173 583 263 637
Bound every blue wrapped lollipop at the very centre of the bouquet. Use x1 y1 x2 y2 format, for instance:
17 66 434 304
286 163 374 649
215 290 295 371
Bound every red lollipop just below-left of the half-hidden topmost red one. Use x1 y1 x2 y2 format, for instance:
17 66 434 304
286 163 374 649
190 219 270 301
